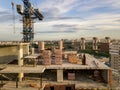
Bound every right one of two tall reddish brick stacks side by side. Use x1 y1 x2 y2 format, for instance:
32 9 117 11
55 50 62 65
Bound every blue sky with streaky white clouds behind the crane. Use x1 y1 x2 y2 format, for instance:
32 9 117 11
0 0 120 40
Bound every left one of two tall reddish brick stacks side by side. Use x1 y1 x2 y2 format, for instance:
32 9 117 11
43 50 51 65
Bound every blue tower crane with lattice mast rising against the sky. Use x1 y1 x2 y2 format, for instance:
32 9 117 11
17 0 44 42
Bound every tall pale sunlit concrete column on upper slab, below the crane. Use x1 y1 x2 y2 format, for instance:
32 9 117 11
18 43 23 66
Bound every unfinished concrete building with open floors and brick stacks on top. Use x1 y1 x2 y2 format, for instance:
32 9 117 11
0 43 112 90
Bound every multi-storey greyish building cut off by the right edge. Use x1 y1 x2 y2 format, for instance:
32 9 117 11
109 42 120 87
